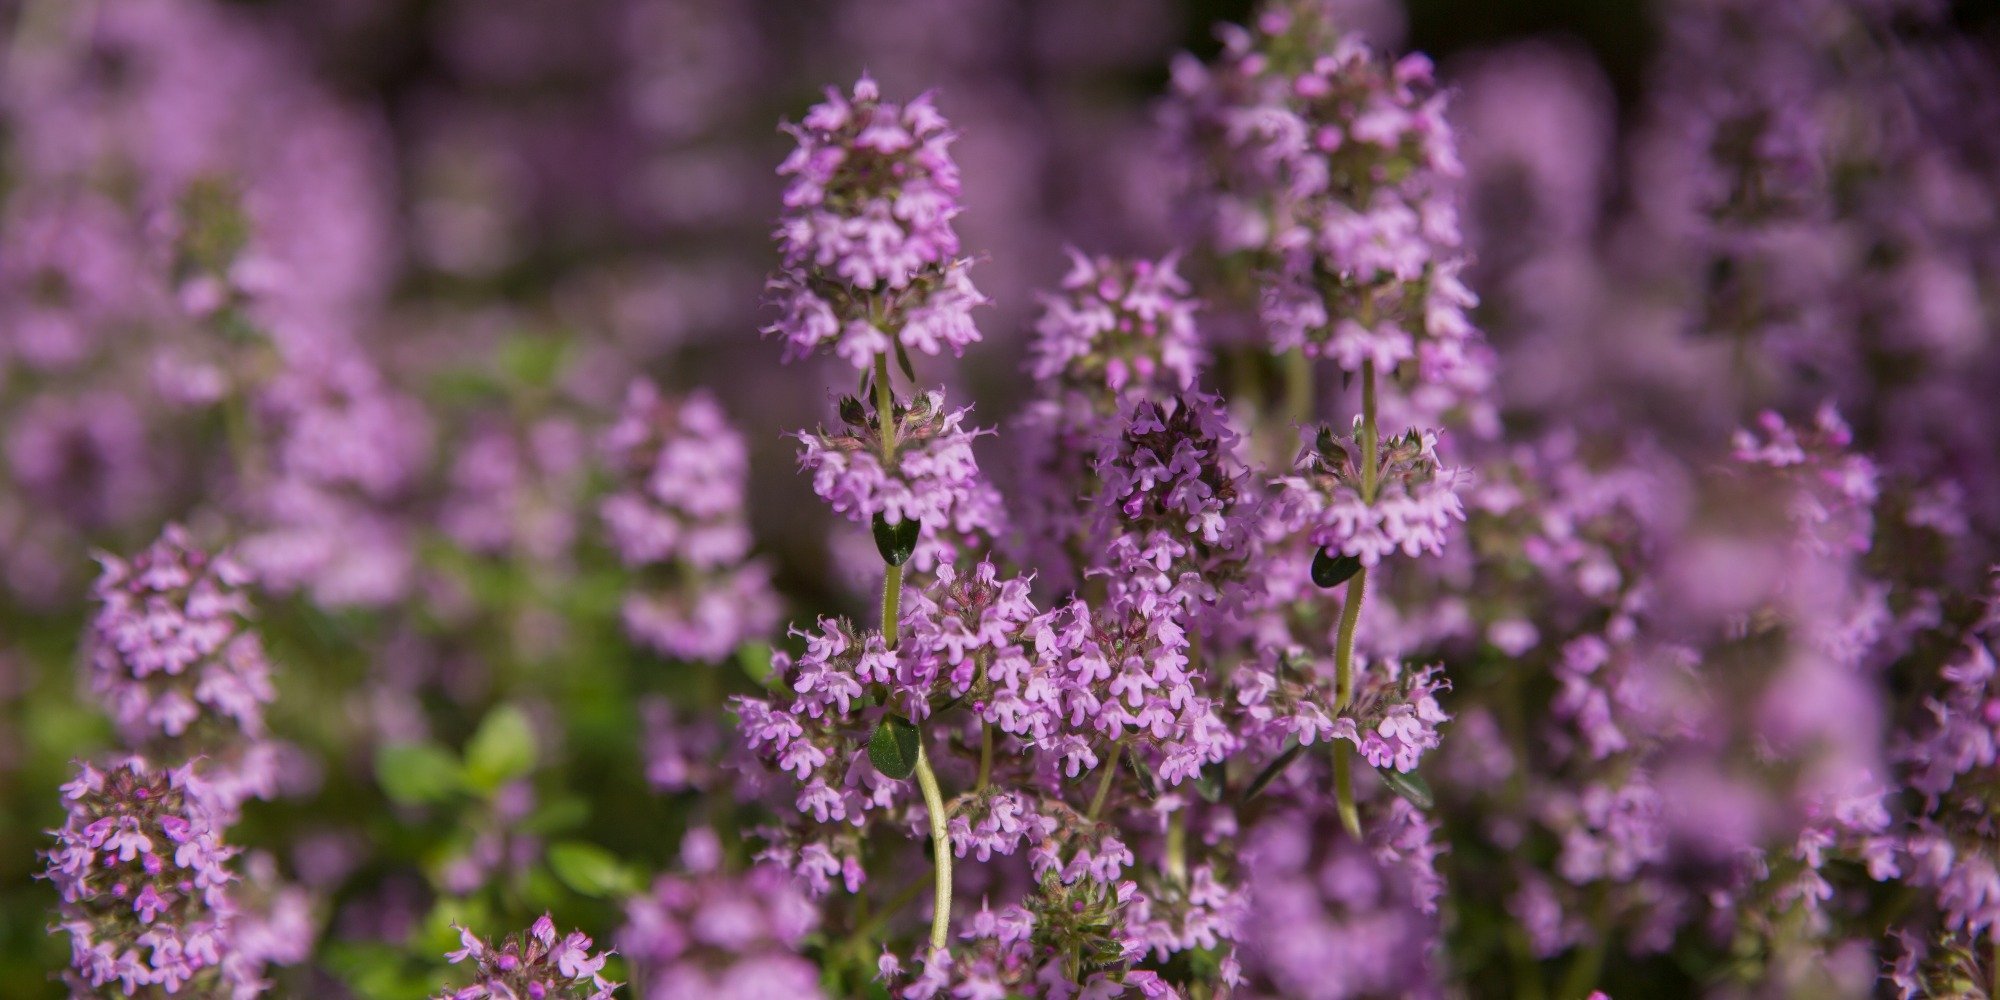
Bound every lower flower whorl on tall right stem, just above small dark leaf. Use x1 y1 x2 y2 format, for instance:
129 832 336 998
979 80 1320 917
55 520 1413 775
1280 422 1468 566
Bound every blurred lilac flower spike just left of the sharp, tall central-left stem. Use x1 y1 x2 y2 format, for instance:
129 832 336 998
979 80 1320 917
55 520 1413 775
600 380 778 660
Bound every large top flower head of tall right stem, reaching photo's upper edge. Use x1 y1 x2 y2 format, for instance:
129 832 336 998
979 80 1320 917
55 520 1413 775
1172 0 1474 378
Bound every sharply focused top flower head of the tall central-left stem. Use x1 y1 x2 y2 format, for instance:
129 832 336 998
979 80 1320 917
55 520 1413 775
766 76 986 368
